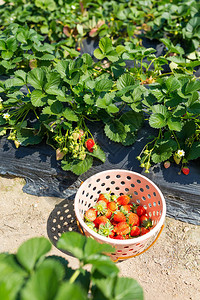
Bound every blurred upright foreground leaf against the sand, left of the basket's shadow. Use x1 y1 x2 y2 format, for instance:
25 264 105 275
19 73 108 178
16 237 51 272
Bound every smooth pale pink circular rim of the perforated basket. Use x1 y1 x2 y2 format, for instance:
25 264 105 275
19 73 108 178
74 169 166 246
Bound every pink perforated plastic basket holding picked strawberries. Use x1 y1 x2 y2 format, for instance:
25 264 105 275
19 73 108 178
74 169 166 261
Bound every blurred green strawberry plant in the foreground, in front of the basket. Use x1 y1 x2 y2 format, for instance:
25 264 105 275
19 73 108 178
0 232 143 300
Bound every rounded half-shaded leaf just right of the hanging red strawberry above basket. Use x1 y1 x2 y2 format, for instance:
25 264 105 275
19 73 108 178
104 120 126 143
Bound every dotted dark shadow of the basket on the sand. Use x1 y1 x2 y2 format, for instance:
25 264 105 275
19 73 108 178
47 194 80 256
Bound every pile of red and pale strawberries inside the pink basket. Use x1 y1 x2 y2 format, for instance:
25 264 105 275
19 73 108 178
84 194 152 240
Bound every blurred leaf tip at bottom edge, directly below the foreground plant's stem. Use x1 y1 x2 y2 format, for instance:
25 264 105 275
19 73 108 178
55 282 88 300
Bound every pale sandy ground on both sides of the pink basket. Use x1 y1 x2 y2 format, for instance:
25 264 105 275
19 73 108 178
0 176 200 300
